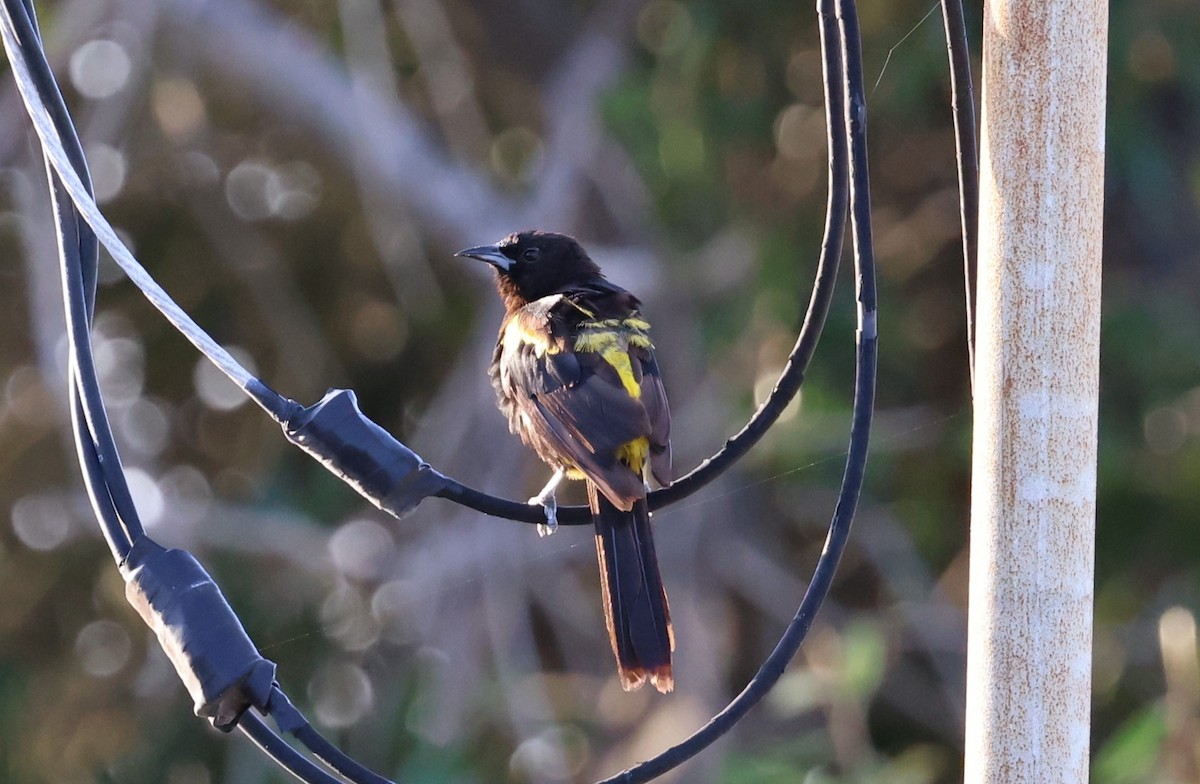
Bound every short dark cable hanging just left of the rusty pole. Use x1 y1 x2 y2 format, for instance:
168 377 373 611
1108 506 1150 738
942 0 979 390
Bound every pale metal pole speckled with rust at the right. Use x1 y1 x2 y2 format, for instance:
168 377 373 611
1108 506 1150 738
965 0 1108 784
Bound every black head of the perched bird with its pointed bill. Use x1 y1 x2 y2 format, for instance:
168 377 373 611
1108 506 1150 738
455 232 601 310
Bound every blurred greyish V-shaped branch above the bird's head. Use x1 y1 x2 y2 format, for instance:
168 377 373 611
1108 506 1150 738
161 0 640 239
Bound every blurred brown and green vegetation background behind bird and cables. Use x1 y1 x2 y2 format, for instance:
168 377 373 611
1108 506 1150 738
0 0 1200 784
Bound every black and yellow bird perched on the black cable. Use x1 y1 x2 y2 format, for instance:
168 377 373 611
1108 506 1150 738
457 232 674 693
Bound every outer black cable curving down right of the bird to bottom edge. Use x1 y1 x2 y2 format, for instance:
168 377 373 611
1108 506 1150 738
599 0 877 784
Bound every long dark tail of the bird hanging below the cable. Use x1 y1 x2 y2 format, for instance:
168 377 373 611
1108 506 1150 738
588 481 674 694
